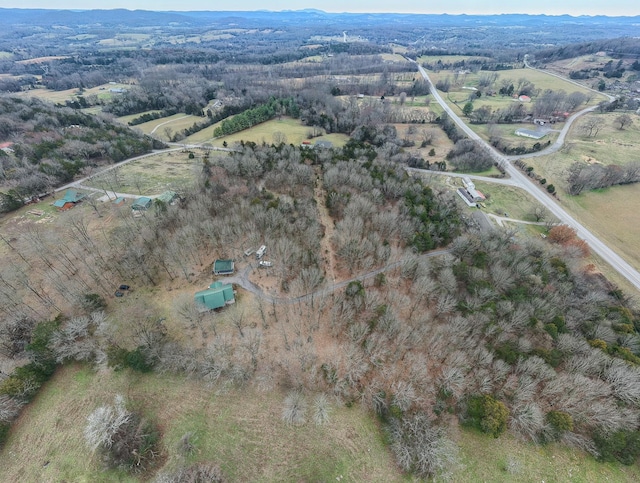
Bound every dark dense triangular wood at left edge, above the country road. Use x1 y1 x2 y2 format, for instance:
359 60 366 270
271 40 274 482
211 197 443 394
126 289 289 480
0 97 161 211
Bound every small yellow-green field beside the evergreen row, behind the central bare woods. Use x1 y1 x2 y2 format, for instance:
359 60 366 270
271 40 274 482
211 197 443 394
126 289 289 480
184 117 349 147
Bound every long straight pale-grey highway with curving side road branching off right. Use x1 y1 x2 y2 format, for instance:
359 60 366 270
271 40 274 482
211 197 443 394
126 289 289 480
415 62 640 290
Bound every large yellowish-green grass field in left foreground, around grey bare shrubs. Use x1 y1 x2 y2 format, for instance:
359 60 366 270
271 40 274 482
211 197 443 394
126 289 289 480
0 366 403 482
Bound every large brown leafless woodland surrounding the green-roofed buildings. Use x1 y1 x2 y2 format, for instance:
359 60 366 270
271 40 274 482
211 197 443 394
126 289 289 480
0 130 640 475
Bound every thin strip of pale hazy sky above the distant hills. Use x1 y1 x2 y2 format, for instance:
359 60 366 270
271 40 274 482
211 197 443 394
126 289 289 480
0 0 640 16
